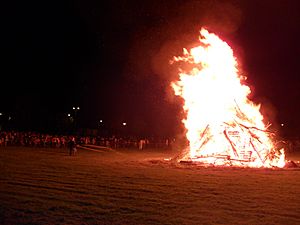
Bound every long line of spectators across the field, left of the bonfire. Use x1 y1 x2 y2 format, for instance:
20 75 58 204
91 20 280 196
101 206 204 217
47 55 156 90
0 131 174 149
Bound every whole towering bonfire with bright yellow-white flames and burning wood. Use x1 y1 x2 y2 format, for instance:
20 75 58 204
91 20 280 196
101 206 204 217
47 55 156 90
172 29 285 167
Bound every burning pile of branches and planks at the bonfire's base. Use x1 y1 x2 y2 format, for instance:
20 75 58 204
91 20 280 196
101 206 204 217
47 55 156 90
184 114 284 167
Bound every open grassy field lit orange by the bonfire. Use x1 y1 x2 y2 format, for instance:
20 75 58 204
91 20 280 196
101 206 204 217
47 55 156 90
0 147 300 225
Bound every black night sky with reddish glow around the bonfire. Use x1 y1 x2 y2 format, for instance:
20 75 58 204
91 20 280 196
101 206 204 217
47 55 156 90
0 0 300 135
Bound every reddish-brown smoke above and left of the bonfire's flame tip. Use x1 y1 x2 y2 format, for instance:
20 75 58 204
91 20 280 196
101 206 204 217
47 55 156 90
126 1 242 101
